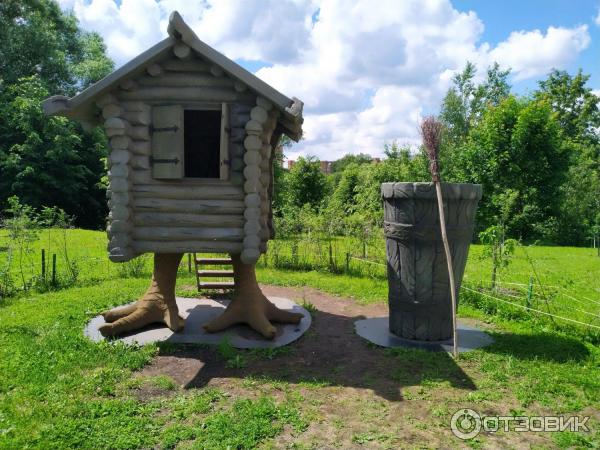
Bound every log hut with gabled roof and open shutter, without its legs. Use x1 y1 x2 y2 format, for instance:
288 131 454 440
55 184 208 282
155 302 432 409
43 12 303 264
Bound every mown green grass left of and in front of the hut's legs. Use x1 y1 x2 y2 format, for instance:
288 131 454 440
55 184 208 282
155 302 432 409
0 279 301 449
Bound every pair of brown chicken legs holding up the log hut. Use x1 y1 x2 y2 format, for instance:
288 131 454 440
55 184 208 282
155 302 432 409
100 253 302 339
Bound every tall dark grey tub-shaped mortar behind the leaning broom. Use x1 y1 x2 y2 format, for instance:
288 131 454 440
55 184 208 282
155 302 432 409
381 183 482 341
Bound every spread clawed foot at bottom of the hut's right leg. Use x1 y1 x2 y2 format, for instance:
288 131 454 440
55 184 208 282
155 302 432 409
203 294 303 339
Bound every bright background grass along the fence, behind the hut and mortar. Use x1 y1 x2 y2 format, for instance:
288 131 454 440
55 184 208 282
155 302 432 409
0 229 600 332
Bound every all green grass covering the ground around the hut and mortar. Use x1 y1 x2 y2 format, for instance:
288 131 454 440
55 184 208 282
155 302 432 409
0 230 600 449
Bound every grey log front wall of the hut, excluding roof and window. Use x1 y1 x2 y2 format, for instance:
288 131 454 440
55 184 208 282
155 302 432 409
97 44 264 263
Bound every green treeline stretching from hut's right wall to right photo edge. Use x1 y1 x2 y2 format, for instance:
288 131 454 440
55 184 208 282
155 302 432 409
275 63 600 245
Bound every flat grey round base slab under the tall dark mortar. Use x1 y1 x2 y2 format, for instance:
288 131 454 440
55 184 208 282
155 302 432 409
354 317 494 353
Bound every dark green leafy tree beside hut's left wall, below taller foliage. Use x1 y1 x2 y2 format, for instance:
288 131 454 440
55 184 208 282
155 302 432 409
0 76 106 228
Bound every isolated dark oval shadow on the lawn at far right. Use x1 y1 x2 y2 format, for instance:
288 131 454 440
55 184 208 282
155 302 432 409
482 333 590 363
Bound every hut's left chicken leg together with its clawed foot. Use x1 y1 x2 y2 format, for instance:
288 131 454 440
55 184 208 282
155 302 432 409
99 253 183 336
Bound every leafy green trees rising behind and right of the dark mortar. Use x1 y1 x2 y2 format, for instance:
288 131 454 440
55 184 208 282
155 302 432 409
440 64 600 243
